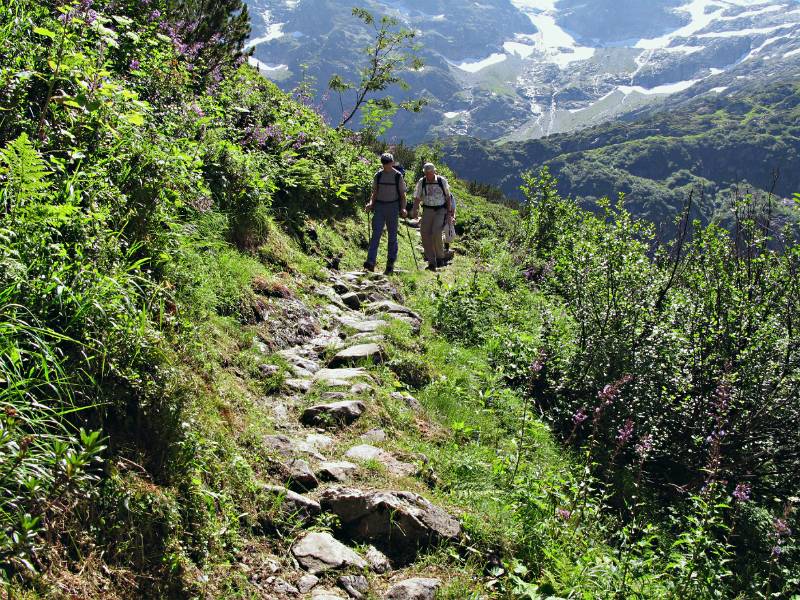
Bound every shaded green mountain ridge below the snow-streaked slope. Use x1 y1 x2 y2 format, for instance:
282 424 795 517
444 80 800 232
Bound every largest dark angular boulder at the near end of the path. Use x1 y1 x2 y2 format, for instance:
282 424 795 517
320 486 461 563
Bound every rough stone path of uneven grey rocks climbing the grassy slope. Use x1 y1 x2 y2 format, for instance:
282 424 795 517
253 272 461 600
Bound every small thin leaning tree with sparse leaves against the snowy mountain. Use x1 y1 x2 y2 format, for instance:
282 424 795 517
328 8 427 131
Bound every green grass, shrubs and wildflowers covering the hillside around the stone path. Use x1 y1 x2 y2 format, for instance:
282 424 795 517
0 0 800 600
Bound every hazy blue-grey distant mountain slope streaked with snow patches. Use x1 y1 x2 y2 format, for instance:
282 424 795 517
242 0 800 142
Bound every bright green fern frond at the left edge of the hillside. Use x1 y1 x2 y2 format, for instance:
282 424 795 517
0 133 51 214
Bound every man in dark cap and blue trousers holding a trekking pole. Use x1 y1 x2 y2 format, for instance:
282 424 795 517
364 152 407 275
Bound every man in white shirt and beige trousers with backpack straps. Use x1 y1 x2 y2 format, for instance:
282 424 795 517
412 163 454 271
